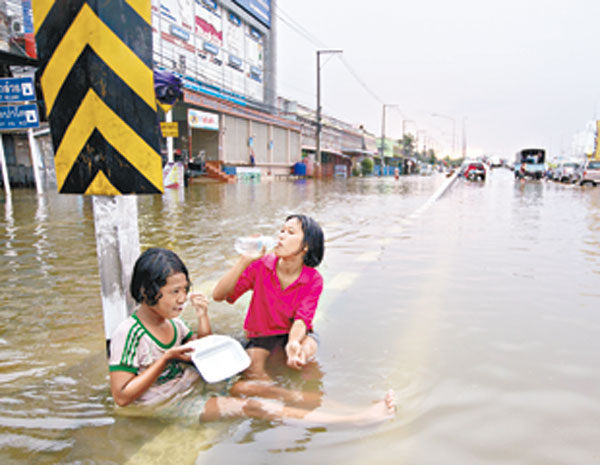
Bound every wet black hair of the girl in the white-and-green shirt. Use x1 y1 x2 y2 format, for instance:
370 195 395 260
129 248 190 305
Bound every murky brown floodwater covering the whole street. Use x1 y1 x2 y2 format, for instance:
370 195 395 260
0 169 600 465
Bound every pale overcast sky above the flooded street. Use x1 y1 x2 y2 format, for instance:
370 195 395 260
273 0 600 159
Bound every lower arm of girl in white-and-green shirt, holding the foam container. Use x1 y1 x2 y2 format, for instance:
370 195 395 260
110 346 193 407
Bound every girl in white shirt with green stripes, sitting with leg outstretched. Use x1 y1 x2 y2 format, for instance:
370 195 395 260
109 248 396 425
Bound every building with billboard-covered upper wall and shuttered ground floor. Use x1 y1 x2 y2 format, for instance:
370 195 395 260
152 0 308 175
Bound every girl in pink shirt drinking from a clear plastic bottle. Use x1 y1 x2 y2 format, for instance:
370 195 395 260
213 215 325 380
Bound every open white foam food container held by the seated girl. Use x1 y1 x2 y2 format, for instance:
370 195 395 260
186 334 250 383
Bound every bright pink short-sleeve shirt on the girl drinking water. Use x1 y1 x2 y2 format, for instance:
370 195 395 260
227 254 323 337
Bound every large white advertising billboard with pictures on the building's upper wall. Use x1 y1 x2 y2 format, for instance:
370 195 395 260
152 0 270 102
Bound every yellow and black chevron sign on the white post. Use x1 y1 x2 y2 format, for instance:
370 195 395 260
33 0 163 195
